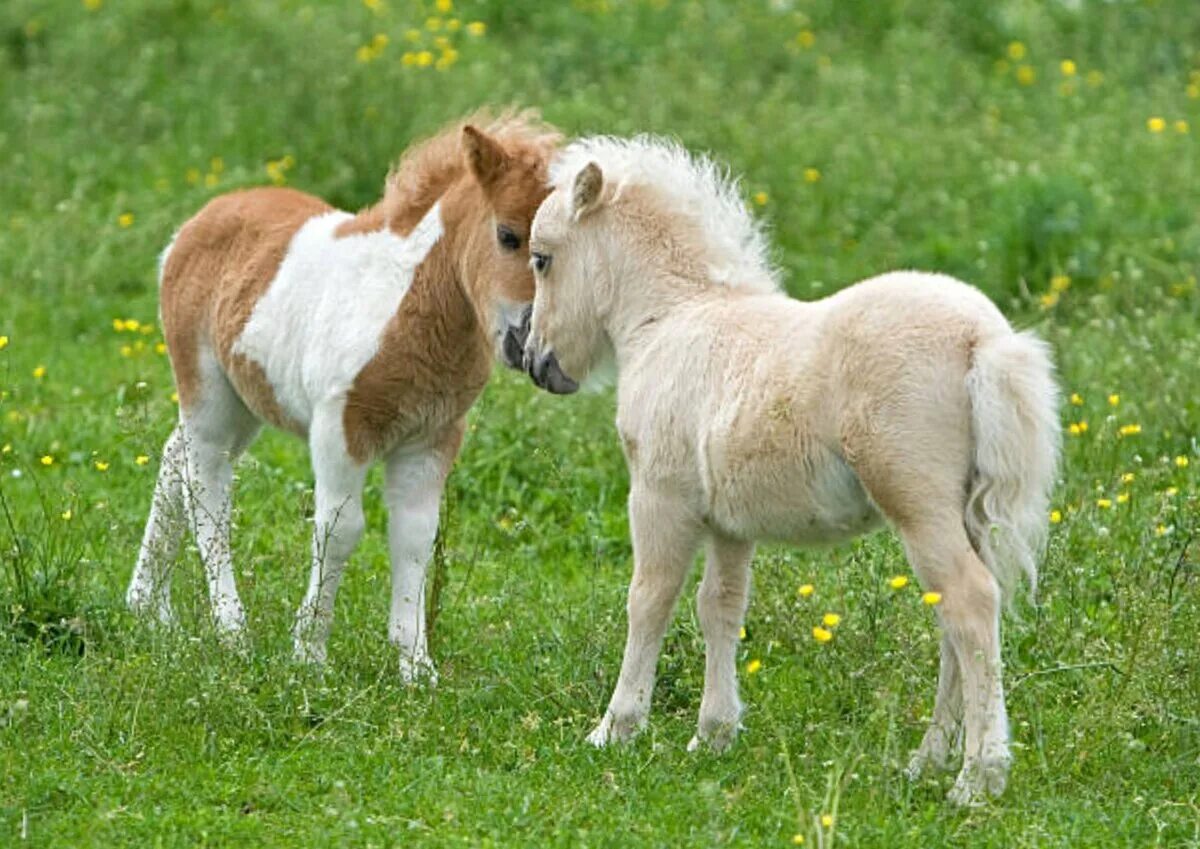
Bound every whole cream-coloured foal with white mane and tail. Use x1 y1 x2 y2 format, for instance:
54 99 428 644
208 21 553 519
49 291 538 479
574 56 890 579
526 138 1060 803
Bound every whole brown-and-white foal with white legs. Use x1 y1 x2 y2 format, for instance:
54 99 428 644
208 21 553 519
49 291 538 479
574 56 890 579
127 114 559 679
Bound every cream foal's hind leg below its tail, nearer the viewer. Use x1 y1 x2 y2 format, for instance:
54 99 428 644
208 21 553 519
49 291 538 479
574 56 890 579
901 522 1012 805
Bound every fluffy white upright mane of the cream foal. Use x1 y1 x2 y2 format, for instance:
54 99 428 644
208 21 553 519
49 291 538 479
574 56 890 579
550 136 780 293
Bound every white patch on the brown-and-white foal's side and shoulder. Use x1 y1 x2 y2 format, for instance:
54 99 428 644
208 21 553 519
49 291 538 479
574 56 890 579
233 204 443 428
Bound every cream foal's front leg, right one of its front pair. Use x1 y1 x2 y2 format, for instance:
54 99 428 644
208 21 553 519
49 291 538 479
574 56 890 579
688 536 754 752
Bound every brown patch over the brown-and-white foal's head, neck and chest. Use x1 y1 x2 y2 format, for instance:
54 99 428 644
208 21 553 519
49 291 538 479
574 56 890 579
341 116 559 462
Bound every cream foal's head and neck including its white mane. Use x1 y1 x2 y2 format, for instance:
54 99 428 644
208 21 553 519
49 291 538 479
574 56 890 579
524 136 779 393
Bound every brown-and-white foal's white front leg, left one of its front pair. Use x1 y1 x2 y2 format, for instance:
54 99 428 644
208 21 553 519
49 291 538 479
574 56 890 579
292 404 370 666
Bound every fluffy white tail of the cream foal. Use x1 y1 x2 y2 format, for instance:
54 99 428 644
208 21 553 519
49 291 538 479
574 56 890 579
964 332 1062 602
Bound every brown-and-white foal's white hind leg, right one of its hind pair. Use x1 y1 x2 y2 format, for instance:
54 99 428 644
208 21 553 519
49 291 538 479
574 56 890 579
182 360 259 636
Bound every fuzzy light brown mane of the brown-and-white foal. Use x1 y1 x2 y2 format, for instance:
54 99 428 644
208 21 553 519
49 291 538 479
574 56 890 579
337 108 563 236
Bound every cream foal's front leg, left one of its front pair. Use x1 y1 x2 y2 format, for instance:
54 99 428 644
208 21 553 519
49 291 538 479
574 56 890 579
588 483 702 746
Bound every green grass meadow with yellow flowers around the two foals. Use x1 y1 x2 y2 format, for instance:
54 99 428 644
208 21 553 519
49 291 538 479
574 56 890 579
0 0 1200 847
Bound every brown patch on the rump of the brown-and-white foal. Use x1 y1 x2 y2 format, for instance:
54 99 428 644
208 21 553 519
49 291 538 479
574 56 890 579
161 187 332 424
